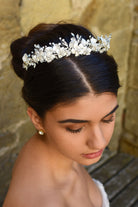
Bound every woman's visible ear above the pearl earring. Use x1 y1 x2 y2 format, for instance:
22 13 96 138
27 107 45 132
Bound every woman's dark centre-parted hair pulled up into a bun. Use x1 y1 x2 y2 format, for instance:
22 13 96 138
11 23 120 117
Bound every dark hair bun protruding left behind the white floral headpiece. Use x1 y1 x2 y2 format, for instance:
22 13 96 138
10 37 28 79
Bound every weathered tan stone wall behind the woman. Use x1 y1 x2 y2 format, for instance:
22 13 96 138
0 0 138 206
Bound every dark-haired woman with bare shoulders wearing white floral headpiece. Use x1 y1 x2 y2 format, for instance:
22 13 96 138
3 23 120 207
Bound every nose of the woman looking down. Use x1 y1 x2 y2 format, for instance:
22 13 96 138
87 125 107 150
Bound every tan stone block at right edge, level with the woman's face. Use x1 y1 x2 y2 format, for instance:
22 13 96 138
125 89 138 136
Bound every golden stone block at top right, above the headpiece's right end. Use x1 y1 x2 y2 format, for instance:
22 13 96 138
84 0 133 33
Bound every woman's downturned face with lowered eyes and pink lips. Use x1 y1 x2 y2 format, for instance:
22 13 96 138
43 93 118 165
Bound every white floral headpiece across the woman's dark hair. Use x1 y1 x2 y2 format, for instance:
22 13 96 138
22 33 111 70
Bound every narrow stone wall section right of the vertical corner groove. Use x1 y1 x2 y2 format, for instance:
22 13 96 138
119 1 138 156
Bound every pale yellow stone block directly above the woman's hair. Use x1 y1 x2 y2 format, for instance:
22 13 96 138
20 0 72 33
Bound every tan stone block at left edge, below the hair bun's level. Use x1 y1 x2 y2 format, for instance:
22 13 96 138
0 68 27 129
